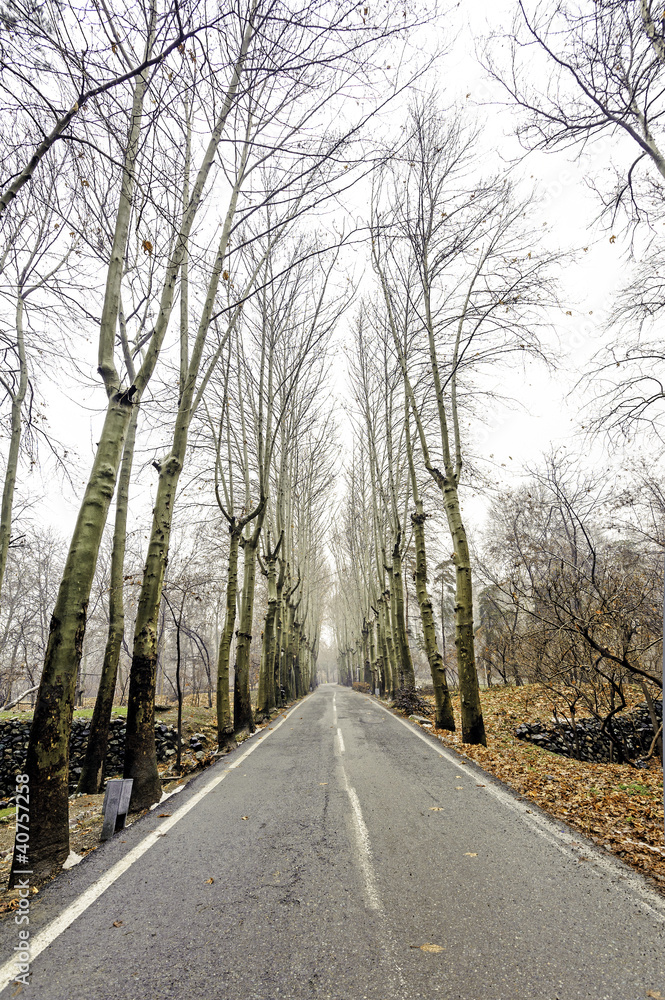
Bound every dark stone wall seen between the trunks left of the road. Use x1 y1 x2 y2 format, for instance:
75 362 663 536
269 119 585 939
0 718 213 799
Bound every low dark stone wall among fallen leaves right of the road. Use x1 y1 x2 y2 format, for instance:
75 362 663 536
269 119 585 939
515 701 663 764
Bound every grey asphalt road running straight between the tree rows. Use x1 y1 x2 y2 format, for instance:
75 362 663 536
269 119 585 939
0 685 665 1000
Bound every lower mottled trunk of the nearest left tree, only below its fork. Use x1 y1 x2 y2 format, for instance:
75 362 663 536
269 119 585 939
11 392 132 885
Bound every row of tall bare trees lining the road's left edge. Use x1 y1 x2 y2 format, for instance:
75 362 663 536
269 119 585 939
0 0 426 877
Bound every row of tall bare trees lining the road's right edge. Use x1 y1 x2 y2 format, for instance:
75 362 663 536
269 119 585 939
330 99 557 743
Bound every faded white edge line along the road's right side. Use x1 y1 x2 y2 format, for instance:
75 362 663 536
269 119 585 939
363 695 665 923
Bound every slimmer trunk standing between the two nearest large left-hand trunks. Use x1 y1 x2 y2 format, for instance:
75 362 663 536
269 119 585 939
77 407 138 795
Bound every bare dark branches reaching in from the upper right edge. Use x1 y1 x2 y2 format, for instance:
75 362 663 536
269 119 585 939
485 0 665 437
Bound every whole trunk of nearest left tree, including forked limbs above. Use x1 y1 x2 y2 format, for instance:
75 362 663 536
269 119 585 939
10 21 172 885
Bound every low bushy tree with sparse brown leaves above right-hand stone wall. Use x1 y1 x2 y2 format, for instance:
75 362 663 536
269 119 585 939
480 455 662 761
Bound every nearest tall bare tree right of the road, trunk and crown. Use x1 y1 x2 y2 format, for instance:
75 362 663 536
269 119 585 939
372 98 553 743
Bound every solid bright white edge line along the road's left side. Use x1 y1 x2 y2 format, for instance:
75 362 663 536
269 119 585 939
0 695 310 993
